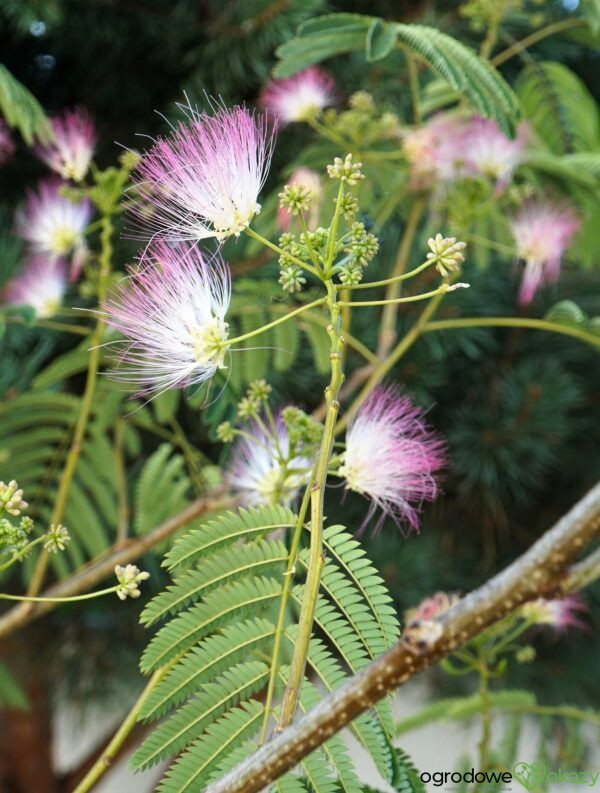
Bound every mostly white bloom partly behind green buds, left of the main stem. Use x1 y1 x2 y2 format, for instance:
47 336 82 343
226 415 312 506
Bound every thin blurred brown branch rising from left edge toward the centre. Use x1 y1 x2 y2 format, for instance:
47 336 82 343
0 494 235 638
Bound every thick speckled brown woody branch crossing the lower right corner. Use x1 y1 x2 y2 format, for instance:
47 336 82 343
205 484 600 793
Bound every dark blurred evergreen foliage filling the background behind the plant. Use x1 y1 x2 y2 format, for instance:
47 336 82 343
0 0 600 744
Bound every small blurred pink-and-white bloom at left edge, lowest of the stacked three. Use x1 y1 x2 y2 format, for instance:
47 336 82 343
3 256 67 318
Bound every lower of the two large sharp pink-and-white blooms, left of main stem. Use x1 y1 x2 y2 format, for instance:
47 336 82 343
103 242 231 393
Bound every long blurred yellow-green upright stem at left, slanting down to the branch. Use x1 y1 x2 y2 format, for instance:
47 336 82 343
27 215 113 596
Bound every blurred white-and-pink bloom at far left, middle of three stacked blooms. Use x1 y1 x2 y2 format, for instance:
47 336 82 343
15 179 92 281
